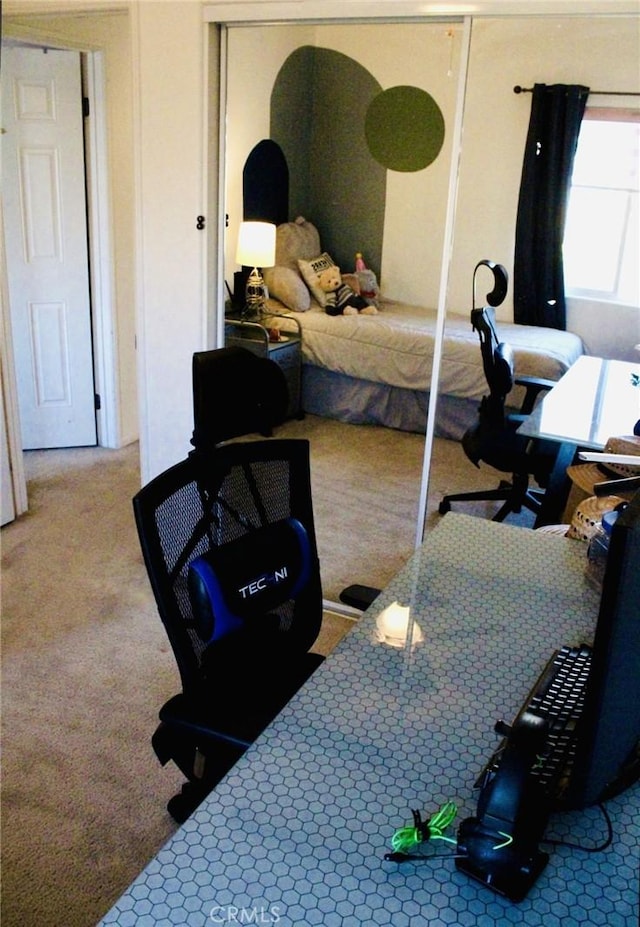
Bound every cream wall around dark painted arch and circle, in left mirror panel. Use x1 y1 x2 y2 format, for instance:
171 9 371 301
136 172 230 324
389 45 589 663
225 23 462 306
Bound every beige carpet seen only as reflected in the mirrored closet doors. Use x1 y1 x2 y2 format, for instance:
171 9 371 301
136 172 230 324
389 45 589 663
278 416 533 601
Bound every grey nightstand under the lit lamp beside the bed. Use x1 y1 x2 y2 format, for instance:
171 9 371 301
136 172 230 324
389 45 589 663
224 312 304 418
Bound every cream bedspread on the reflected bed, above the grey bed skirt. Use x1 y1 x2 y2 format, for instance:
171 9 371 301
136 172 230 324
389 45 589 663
270 300 583 399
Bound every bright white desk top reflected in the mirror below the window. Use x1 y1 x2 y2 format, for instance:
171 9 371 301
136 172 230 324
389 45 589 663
518 355 640 450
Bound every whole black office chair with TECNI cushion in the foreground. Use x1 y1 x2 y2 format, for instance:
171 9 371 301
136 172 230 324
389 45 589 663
133 348 323 822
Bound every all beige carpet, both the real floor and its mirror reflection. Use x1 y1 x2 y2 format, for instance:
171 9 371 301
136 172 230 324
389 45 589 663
2 418 532 927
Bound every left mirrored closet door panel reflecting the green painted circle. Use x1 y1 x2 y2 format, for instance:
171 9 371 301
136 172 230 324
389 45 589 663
225 21 463 600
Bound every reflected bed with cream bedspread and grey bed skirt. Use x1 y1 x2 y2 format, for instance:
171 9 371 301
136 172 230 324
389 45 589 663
267 299 583 440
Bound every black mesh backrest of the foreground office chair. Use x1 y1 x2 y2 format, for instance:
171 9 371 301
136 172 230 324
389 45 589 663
133 439 322 693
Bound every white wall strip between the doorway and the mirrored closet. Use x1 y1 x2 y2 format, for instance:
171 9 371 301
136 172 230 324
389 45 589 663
132 0 208 481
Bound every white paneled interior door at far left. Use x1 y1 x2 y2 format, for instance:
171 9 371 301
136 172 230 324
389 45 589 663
2 47 96 449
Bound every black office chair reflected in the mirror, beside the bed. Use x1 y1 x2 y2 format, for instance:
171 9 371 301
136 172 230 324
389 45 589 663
438 260 555 521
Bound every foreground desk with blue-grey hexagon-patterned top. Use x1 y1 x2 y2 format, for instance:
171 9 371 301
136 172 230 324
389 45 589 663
97 514 640 927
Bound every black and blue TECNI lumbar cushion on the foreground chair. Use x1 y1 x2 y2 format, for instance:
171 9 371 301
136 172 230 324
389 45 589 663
187 518 311 643
